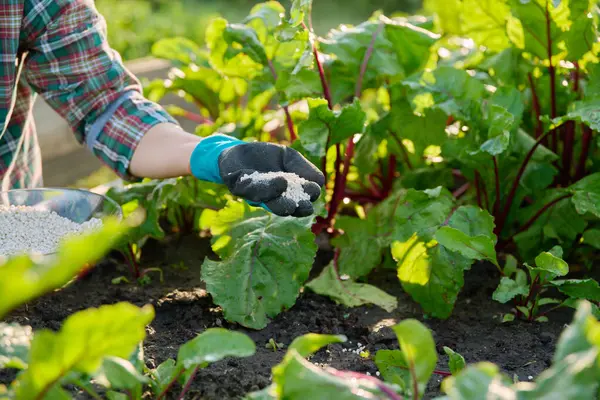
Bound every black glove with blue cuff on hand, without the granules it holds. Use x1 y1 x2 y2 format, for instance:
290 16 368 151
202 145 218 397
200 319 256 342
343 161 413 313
190 134 325 217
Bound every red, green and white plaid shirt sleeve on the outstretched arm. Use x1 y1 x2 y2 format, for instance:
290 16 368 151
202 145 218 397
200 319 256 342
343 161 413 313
22 0 177 181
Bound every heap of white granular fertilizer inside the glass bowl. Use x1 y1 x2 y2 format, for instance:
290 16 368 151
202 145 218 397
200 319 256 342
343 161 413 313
0 205 102 258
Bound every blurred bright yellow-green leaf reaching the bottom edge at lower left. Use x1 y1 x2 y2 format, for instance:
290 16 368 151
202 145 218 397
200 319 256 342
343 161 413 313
16 303 154 399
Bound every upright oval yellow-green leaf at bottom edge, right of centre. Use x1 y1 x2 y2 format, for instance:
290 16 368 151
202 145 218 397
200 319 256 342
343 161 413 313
392 319 438 398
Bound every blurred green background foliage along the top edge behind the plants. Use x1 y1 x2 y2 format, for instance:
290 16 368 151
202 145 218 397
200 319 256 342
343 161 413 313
96 0 421 60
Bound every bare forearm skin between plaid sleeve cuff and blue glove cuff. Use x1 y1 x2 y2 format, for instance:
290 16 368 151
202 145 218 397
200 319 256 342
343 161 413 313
129 123 202 179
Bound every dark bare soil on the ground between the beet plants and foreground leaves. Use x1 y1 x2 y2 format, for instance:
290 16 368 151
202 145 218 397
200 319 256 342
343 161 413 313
0 233 573 400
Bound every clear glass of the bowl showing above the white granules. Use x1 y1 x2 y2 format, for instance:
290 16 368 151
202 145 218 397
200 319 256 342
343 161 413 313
0 188 123 257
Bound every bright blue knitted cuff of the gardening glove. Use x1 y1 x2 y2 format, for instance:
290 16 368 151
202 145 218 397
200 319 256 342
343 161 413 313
190 133 244 184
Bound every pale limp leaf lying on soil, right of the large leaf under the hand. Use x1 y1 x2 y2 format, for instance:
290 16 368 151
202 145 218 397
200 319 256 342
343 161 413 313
306 258 398 312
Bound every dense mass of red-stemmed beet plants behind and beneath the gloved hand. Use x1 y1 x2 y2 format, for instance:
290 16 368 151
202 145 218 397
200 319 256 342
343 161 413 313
104 0 600 328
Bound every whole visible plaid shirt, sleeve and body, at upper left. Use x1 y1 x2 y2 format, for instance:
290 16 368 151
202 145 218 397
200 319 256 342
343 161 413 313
0 0 176 190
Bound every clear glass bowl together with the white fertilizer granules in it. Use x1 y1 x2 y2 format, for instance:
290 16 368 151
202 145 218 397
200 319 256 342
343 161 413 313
0 188 122 258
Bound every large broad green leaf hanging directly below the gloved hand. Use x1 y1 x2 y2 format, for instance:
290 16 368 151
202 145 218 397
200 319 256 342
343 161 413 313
202 202 317 329
